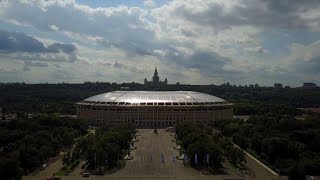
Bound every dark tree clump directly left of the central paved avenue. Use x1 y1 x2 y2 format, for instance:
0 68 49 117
64 124 136 173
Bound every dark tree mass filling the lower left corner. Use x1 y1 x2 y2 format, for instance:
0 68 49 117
0 115 88 179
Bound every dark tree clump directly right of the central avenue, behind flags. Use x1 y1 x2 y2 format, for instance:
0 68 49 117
176 123 245 172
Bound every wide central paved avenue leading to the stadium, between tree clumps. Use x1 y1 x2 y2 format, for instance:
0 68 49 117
104 129 239 180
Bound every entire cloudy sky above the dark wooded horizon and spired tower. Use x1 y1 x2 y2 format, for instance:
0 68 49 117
0 0 320 86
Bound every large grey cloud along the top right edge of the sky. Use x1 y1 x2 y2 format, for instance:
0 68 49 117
159 0 320 31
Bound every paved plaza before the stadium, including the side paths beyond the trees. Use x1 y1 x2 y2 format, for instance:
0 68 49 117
24 129 277 180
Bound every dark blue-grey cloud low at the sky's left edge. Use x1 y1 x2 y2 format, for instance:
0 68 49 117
0 30 76 54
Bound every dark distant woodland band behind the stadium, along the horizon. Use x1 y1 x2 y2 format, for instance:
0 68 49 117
0 82 320 114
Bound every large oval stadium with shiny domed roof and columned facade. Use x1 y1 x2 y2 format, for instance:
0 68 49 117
76 91 233 128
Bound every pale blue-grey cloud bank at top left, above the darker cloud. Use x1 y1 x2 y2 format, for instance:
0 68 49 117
0 0 154 51
